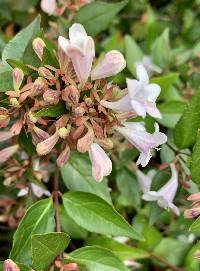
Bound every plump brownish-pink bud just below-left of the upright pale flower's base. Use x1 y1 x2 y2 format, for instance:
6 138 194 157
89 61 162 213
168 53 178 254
62 85 80 106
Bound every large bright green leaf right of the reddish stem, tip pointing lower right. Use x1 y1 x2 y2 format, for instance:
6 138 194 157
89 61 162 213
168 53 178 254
63 192 141 239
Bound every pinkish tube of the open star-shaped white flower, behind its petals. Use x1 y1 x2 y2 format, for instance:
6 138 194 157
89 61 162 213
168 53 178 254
101 95 132 112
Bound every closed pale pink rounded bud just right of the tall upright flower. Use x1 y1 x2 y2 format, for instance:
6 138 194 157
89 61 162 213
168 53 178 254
91 50 126 80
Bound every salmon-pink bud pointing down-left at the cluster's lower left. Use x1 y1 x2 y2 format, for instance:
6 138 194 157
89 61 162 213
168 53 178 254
36 132 59 155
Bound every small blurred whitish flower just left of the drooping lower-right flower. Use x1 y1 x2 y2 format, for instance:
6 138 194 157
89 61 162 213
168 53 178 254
135 169 156 193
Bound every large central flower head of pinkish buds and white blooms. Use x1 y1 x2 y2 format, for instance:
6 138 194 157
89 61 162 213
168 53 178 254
0 24 167 181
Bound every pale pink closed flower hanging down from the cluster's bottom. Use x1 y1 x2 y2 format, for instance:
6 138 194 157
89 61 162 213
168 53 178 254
88 143 112 182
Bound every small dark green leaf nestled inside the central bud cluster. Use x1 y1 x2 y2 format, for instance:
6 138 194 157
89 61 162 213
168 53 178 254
36 102 67 118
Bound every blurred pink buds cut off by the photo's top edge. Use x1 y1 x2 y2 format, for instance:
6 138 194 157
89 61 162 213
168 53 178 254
41 0 91 16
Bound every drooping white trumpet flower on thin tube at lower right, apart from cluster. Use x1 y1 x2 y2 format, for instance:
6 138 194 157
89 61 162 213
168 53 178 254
142 164 180 215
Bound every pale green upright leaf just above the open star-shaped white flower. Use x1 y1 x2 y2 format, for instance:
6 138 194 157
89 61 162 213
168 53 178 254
124 35 144 76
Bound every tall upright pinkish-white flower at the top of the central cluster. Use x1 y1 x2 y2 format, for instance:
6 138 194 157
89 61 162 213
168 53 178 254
58 24 95 83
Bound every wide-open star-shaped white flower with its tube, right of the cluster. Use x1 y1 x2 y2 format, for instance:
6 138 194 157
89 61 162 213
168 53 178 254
101 64 161 118
